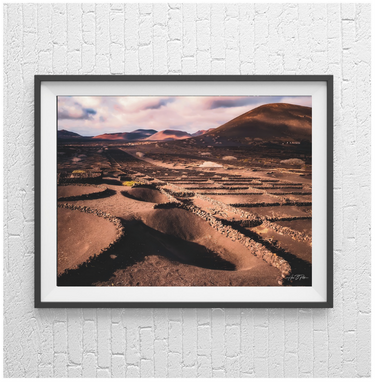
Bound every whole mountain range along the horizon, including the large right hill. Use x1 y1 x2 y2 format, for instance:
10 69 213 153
57 103 312 145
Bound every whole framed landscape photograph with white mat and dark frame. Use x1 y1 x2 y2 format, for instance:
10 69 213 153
35 75 333 308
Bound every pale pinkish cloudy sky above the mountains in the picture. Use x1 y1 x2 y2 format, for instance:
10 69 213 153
57 96 311 136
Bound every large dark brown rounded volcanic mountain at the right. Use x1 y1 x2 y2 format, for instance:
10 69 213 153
203 103 311 142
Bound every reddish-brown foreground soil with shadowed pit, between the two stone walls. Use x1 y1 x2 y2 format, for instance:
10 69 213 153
59 182 280 286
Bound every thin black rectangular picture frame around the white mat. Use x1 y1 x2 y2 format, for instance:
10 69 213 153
34 75 333 308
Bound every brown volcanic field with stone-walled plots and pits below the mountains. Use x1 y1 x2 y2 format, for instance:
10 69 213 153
57 142 312 286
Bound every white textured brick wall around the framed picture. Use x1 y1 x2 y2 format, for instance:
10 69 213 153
4 4 370 377
